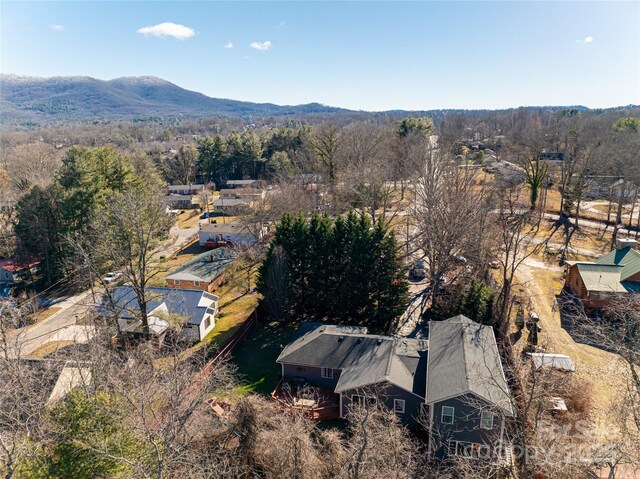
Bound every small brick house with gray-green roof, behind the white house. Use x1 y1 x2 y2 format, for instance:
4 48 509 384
165 248 236 292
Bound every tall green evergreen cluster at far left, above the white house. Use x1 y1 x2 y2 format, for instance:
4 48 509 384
14 147 160 283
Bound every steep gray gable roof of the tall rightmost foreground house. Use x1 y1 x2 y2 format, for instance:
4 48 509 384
426 315 513 415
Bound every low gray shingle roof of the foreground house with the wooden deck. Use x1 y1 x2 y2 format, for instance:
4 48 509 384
277 323 427 397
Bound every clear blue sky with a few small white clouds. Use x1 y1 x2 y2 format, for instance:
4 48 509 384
0 0 640 110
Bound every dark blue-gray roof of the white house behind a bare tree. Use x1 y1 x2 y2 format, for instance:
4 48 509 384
98 285 218 325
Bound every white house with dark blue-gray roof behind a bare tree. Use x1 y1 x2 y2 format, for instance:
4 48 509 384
98 285 218 343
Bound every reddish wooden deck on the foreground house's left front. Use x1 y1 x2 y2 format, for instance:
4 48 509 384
271 379 340 421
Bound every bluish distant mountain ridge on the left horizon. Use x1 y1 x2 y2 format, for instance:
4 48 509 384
0 74 349 123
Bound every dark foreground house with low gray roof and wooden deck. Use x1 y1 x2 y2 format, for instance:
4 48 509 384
274 323 427 427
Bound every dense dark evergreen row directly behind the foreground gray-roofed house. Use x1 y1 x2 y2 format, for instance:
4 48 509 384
258 212 407 329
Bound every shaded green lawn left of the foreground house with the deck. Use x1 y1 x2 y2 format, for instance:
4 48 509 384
232 322 295 395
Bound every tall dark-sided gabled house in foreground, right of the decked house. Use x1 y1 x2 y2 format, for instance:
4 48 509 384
425 315 514 459
